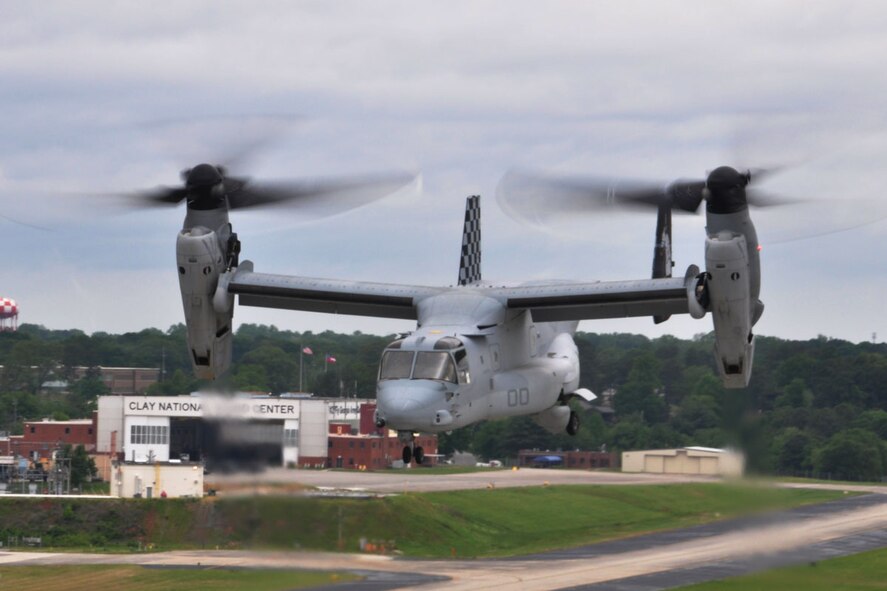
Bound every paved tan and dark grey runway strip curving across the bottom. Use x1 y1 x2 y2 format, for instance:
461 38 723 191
0 494 887 591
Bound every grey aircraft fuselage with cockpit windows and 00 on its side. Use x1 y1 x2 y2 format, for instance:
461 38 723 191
376 288 579 433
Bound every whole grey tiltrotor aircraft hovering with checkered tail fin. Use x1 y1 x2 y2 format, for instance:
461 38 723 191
149 164 763 463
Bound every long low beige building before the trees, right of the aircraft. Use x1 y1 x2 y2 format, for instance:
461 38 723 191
622 447 745 476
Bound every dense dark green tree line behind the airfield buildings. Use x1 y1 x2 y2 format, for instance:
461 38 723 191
0 324 887 480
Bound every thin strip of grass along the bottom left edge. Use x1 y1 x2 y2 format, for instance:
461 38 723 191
0 565 359 591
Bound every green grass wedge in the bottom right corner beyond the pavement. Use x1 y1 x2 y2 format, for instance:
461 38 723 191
681 549 887 591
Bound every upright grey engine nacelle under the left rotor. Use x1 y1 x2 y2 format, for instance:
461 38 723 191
176 226 234 380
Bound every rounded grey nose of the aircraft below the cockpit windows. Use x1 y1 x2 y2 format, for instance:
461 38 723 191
376 380 446 430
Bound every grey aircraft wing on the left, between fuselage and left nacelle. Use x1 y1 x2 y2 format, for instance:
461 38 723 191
228 261 445 320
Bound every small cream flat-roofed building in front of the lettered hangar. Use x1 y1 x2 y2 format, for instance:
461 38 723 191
111 463 203 499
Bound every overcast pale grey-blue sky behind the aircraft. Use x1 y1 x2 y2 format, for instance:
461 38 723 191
0 0 887 341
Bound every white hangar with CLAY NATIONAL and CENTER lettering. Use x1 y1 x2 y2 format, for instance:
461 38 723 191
96 395 366 468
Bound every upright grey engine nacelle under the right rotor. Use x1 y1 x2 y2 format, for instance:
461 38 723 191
703 230 760 388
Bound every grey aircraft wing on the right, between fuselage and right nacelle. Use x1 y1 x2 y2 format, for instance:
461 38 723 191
489 275 695 322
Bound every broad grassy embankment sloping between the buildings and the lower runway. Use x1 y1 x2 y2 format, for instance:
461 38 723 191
0 483 843 557
